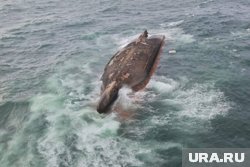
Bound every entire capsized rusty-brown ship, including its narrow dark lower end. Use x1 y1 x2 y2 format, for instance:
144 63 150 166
97 30 165 113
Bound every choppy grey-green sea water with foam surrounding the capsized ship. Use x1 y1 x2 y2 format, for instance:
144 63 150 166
0 0 250 167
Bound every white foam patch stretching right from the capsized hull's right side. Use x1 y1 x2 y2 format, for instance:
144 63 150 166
149 77 231 120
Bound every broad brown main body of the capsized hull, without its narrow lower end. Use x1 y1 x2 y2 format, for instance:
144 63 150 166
102 33 164 91
